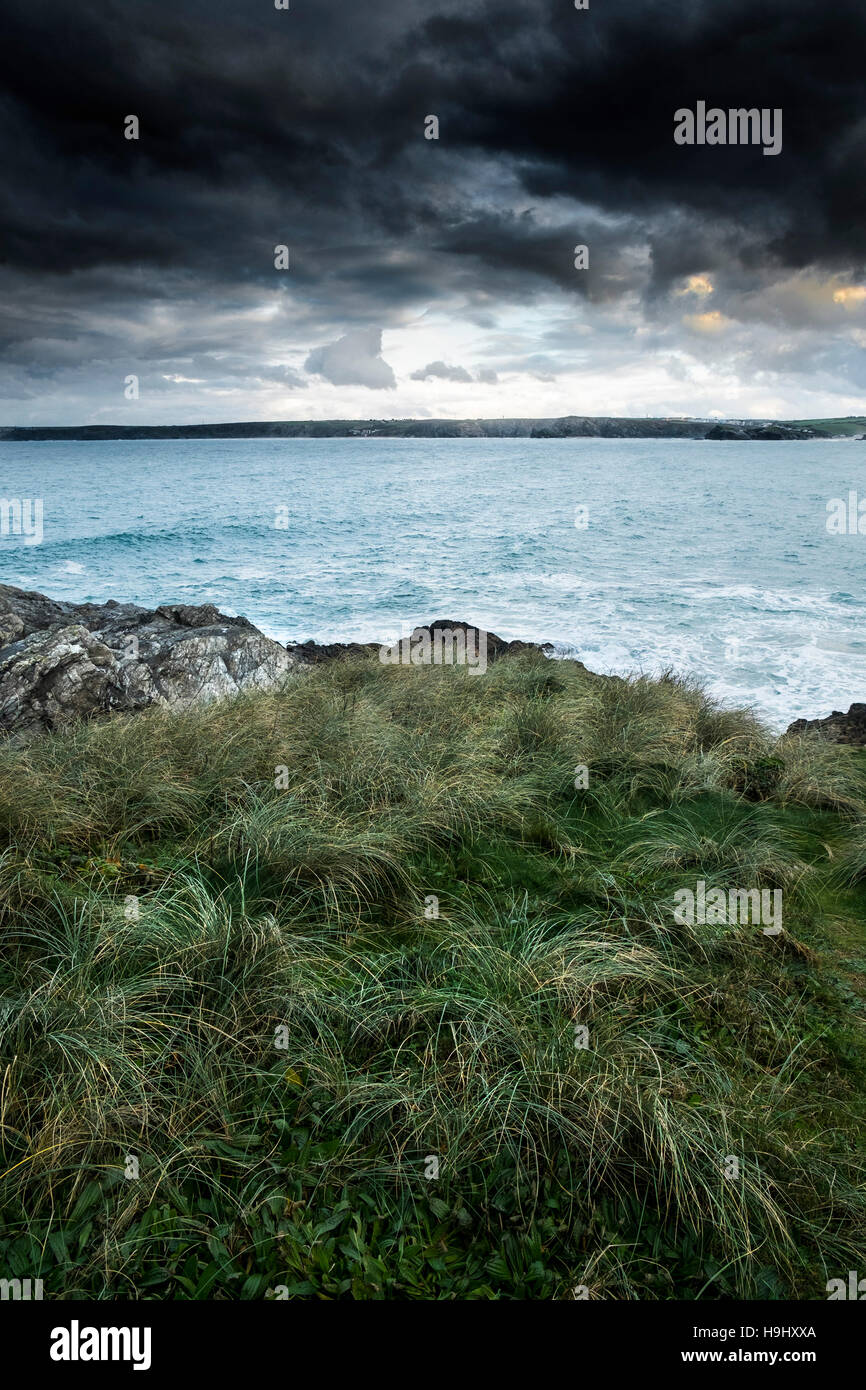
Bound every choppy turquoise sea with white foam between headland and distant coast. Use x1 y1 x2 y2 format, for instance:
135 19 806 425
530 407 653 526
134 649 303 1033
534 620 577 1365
0 439 866 726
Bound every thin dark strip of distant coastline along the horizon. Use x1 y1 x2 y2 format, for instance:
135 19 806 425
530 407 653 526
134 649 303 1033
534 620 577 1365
0 416 866 443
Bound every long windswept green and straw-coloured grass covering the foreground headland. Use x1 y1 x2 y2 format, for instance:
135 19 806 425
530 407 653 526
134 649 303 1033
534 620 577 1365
0 655 866 1300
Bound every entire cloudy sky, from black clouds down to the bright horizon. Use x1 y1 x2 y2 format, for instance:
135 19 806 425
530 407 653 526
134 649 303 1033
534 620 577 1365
0 0 866 425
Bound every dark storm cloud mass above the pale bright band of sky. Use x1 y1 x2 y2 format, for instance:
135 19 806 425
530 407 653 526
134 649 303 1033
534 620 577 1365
0 0 866 408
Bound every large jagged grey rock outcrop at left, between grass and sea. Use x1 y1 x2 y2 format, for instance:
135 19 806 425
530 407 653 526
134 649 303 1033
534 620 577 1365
0 585 297 738
